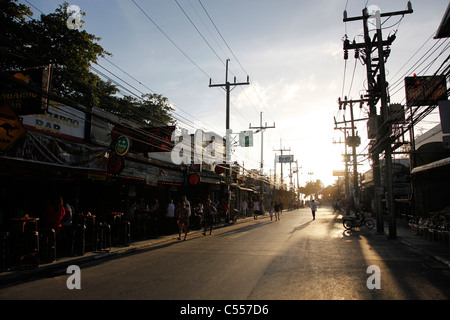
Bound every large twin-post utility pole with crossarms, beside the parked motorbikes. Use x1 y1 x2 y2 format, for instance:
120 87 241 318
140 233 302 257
343 1 413 239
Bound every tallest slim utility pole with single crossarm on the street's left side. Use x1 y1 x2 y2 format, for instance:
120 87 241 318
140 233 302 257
209 59 250 219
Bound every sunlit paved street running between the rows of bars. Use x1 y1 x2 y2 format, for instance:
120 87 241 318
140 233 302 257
0 206 450 300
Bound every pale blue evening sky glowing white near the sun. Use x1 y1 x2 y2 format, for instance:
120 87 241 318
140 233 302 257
19 0 448 186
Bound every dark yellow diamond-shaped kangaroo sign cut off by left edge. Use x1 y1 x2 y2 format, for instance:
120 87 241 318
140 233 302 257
0 104 26 151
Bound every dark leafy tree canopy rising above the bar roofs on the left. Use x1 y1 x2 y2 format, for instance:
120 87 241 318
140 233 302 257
0 0 174 126
